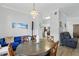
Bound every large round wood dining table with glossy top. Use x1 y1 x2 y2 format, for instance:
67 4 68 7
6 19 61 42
15 39 53 56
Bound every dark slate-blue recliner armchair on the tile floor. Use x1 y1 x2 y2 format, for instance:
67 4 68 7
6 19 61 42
60 32 77 48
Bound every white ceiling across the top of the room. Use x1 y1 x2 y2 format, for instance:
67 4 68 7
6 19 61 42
0 3 79 17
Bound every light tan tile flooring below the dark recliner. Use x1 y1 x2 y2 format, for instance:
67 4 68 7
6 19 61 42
57 39 79 56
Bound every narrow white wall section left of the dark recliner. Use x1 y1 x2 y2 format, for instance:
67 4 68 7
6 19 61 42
50 9 59 41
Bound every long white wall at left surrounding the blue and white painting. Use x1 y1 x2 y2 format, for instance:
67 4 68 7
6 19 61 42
0 7 32 37
